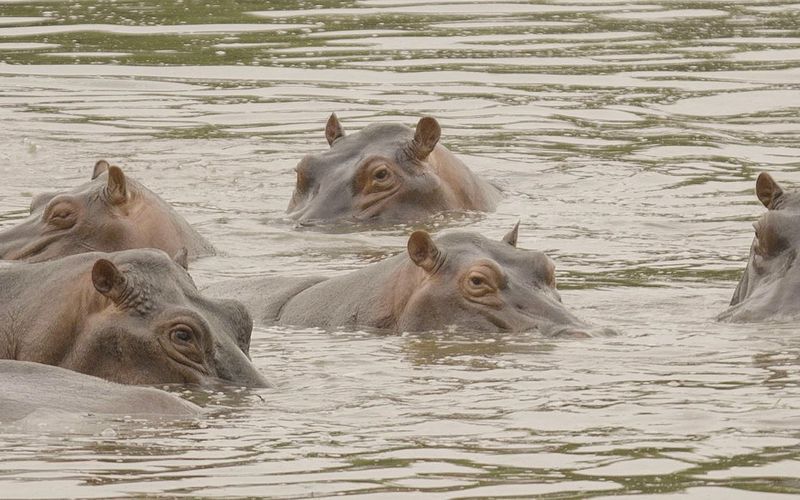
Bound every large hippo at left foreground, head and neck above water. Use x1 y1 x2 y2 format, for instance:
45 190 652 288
0 249 266 387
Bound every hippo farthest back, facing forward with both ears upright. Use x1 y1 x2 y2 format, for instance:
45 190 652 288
287 114 500 224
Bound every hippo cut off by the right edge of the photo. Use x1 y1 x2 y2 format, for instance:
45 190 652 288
719 173 800 322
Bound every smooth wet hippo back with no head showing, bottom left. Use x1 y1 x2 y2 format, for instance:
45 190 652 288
0 360 202 424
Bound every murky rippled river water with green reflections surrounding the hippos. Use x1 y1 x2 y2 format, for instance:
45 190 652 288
0 0 800 498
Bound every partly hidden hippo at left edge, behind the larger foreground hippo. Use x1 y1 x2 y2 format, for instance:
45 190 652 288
0 160 214 262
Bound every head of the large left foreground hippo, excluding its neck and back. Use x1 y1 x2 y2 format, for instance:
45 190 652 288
58 249 266 387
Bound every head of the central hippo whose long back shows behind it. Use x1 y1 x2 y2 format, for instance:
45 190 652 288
398 224 589 337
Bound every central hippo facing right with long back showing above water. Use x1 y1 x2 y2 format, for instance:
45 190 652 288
207 227 588 337
